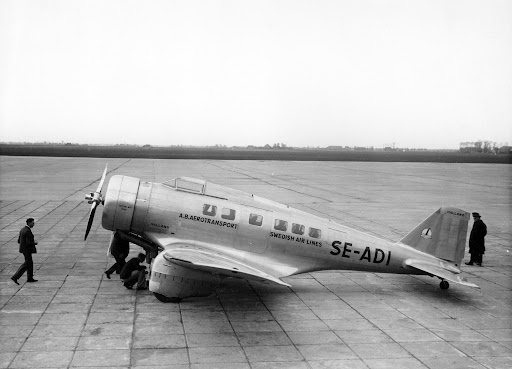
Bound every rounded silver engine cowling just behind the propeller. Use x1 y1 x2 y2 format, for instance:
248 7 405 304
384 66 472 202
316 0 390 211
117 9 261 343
101 176 140 231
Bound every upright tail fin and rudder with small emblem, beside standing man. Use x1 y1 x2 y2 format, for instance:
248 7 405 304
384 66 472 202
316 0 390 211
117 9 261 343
399 207 469 266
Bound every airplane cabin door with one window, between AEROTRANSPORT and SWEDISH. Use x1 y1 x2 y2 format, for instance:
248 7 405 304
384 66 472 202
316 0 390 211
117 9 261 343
235 206 273 254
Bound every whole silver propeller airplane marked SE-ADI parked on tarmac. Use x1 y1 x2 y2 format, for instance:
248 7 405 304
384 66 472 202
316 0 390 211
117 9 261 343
84 166 479 303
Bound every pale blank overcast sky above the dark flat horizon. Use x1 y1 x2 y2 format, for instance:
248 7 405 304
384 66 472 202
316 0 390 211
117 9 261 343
0 0 512 148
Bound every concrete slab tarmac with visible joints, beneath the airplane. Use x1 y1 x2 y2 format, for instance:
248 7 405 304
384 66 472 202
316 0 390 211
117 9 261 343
0 157 512 369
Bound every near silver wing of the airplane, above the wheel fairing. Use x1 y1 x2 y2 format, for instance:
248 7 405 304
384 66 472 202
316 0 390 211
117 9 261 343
163 245 291 287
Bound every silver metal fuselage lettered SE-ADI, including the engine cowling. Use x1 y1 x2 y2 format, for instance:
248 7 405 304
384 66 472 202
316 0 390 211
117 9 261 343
102 176 438 278
